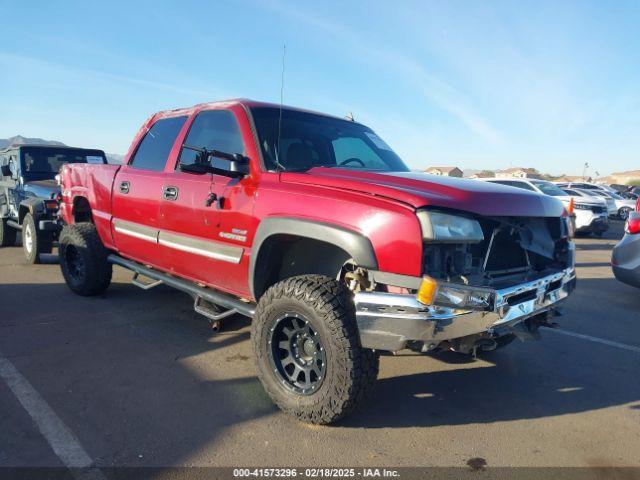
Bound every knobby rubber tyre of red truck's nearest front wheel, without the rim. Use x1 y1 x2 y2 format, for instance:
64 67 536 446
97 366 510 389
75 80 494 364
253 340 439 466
251 275 379 424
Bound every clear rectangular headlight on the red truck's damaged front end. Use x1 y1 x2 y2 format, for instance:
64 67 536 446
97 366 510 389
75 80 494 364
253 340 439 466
418 210 484 243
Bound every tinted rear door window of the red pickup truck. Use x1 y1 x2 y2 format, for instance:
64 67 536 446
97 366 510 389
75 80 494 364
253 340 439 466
129 117 187 172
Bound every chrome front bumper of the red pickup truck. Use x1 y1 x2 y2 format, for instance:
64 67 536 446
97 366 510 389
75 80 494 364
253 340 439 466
354 268 576 352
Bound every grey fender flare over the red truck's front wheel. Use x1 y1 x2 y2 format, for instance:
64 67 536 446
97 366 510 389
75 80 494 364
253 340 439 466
249 217 378 299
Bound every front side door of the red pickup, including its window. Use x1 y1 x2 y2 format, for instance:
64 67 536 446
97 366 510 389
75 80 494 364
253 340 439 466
159 109 253 295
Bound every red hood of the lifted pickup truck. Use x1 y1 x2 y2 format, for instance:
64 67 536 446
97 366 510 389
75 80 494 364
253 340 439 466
281 167 564 217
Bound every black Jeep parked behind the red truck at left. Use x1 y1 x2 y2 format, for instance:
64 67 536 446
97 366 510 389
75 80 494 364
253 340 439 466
0 145 107 263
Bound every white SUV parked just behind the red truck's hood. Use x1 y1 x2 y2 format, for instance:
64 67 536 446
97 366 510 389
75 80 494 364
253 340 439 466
479 178 609 235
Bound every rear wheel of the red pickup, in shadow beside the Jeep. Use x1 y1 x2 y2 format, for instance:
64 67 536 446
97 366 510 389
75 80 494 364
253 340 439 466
58 223 113 297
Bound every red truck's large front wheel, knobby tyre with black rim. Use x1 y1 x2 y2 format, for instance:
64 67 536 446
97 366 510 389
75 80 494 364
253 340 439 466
252 275 379 425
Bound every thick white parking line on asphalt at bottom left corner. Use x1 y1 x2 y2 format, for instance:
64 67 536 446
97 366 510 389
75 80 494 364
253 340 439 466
0 355 105 480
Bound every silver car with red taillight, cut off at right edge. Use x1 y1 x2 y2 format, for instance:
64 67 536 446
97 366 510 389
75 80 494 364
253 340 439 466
611 212 640 288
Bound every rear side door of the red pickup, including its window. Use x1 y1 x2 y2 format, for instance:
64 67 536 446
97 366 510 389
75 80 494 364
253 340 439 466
111 116 187 267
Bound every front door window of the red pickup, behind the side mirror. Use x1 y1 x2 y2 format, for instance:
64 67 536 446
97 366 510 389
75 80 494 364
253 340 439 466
178 110 245 165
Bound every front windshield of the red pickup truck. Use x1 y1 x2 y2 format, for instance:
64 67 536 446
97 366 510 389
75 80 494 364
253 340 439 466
251 107 409 172
